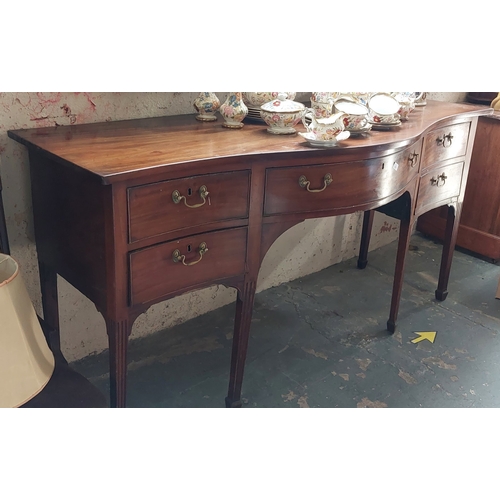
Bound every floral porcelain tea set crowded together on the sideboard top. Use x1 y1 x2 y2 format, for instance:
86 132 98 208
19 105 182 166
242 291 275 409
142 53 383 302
195 92 426 147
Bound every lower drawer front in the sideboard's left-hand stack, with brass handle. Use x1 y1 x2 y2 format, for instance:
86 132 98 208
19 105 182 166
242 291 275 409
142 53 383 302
130 228 247 305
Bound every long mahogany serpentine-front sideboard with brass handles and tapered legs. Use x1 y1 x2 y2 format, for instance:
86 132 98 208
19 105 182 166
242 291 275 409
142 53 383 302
8 102 492 407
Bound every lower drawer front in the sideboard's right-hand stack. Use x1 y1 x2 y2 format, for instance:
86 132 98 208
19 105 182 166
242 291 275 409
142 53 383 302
416 162 464 214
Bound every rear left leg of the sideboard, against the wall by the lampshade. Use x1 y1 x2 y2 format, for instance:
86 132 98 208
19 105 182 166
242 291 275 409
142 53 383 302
38 262 61 353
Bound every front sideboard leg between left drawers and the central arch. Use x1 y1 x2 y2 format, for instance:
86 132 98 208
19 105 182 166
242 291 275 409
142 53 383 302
226 282 256 408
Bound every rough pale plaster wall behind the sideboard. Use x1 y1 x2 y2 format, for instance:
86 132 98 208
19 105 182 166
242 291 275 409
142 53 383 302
0 92 465 361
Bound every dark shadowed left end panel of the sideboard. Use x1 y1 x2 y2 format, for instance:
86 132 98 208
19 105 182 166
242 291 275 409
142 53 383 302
30 152 109 309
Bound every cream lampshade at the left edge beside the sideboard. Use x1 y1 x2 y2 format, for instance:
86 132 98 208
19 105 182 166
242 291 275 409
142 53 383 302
0 253 55 408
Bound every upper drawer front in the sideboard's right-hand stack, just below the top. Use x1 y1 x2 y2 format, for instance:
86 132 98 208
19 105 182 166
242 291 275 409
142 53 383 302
422 122 470 169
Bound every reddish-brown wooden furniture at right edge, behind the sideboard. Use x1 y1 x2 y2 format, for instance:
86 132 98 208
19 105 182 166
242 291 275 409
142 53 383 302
417 111 500 261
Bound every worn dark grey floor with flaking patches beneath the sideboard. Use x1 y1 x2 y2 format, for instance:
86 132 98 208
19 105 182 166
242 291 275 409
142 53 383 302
72 233 500 408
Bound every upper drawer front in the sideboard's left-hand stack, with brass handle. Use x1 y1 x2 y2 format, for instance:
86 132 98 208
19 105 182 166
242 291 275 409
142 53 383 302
128 171 250 243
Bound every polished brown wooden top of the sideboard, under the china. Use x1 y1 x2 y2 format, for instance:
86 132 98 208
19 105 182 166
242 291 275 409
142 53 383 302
8 101 493 184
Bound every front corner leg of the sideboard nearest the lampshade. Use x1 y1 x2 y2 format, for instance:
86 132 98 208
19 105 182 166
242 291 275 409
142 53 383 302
106 319 132 408
